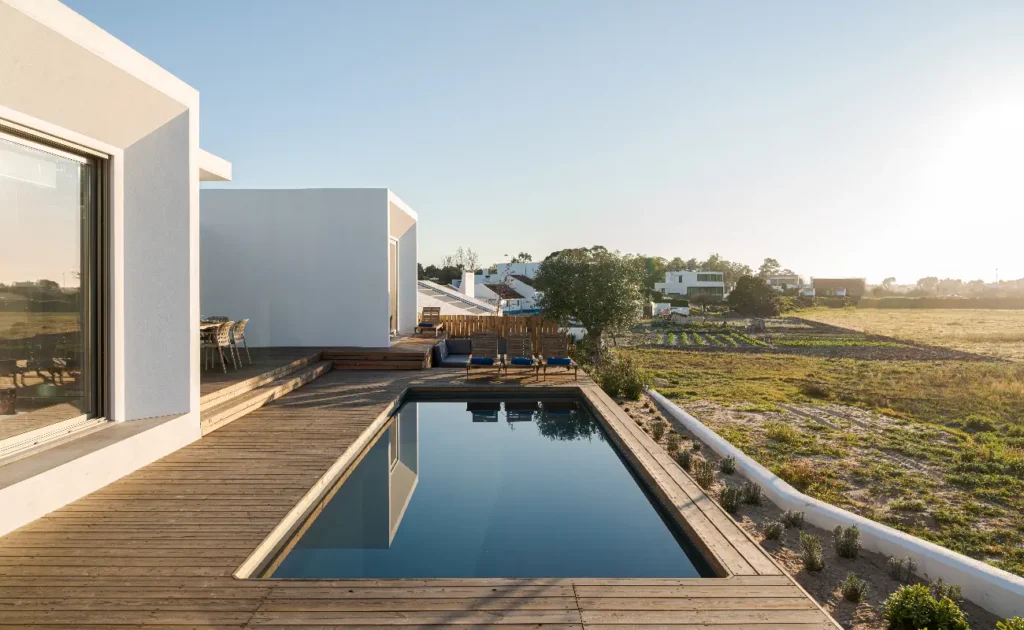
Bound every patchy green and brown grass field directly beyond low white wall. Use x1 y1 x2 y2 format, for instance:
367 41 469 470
622 348 1024 575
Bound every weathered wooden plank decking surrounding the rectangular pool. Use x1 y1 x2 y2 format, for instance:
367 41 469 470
0 370 839 630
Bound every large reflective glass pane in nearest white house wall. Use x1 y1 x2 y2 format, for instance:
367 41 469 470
0 133 98 428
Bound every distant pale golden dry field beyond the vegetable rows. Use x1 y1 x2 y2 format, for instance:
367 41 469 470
797 308 1024 361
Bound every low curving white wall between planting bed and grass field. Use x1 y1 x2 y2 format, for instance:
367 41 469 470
649 389 1024 617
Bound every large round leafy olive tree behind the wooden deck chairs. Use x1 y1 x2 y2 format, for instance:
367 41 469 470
535 247 647 348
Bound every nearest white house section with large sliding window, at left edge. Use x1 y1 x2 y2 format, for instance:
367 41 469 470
0 0 231 535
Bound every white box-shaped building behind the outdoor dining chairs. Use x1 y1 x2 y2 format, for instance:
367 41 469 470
201 188 418 347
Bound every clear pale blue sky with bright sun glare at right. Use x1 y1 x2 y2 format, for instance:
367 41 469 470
68 0 1024 283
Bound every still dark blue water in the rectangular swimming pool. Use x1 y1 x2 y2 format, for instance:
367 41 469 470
273 401 714 578
